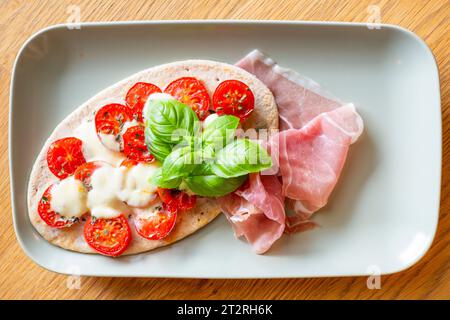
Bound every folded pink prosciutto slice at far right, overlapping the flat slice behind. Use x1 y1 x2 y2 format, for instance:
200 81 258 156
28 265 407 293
269 104 363 211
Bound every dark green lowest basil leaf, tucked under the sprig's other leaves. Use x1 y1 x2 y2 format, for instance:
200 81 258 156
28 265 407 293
183 174 247 197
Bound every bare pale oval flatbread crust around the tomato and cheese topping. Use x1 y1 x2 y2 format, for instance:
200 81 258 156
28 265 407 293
28 60 278 254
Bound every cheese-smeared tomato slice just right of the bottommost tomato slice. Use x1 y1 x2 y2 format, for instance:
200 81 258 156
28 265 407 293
134 204 177 240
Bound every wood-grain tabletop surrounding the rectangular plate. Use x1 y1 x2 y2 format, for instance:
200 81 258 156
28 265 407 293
0 0 450 299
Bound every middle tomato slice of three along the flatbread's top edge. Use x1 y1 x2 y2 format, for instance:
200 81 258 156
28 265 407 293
164 77 209 120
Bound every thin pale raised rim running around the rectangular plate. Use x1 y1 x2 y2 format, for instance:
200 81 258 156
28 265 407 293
8 19 442 279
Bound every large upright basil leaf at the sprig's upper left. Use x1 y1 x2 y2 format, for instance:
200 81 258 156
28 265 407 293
144 99 200 162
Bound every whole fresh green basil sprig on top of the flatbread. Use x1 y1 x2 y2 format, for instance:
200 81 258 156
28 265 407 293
144 98 272 197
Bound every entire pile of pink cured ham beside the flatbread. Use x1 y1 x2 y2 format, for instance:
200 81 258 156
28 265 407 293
219 50 364 253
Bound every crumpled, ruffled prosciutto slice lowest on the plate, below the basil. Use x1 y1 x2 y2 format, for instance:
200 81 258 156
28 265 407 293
218 173 286 254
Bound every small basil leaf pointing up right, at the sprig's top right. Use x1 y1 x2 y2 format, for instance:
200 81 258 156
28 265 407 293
202 115 239 150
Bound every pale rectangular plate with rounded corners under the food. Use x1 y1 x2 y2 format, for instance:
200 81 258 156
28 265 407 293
9 21 441 278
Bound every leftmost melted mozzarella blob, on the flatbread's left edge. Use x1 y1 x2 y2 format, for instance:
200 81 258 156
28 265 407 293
50 176 88 218
